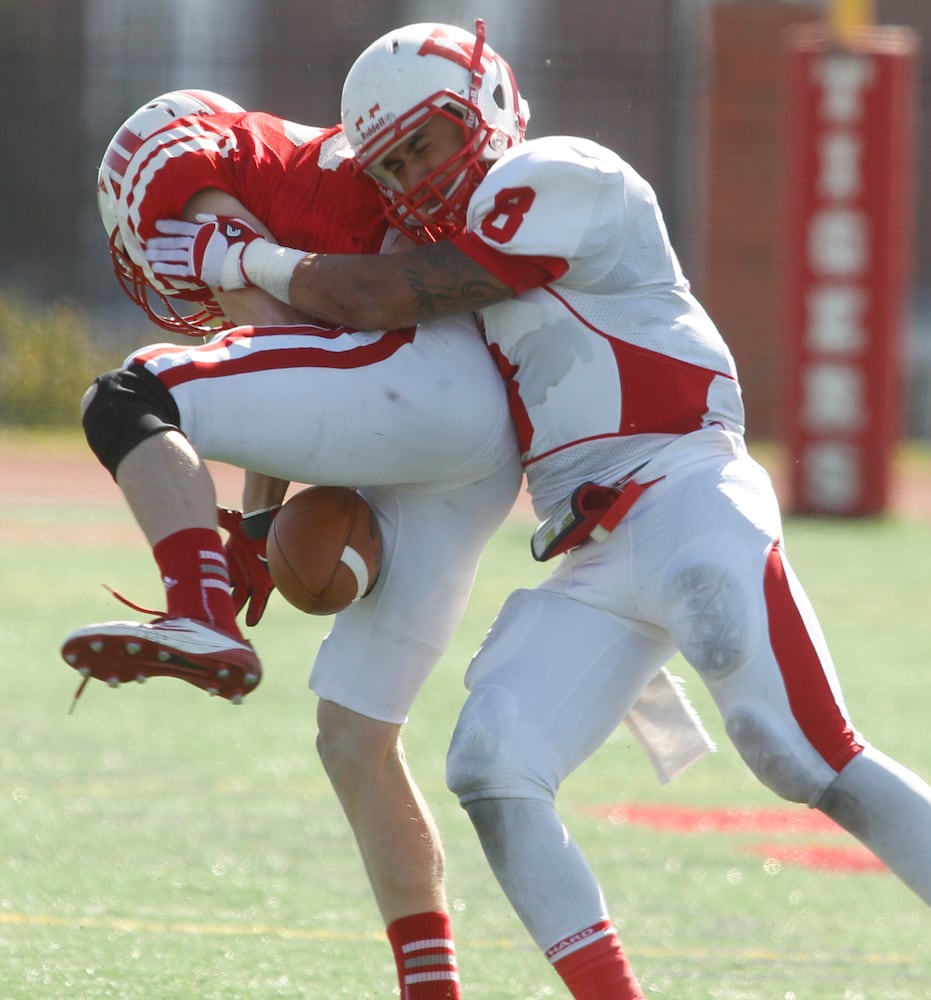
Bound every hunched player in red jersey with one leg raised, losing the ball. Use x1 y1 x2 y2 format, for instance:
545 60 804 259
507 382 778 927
62 91 520 1000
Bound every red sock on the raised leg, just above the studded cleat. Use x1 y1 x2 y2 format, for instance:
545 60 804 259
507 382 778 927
152 528 240 636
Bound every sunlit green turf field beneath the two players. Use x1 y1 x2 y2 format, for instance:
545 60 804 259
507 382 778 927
0 442 931 1000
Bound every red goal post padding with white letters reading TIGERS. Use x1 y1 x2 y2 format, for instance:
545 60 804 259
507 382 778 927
784 25 918 516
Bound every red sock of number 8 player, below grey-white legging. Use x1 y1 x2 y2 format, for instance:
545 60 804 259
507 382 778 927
546 920 643 1000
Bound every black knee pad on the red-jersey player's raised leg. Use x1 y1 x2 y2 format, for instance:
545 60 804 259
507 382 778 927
83 364 181 479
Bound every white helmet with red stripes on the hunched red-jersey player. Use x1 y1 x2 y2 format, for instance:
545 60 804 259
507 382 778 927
97 90 245 336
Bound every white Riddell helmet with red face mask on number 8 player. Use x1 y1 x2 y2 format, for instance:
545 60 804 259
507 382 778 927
341 20 530 242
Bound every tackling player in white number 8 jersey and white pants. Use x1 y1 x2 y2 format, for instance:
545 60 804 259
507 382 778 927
147 22 931 1000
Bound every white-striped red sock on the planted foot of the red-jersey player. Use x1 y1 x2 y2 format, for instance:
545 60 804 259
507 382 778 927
388 912 462 1000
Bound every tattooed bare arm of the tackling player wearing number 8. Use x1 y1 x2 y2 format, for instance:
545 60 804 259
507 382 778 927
290 242 513 330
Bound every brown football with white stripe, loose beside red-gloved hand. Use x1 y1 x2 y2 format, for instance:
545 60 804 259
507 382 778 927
268 486 382 615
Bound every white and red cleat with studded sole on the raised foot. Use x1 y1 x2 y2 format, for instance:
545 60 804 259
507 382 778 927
61 617 262 705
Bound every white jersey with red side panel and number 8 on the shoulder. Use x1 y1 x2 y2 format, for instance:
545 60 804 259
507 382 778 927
455 136 744 513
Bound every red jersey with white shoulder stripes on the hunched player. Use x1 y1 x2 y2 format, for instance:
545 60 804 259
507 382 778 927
114 112 387 265
